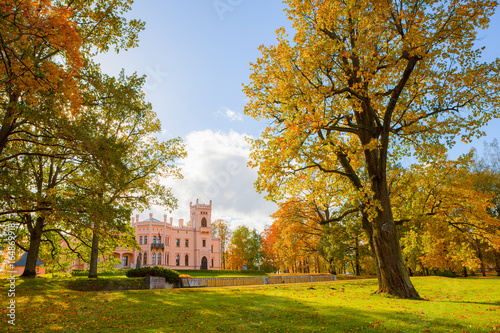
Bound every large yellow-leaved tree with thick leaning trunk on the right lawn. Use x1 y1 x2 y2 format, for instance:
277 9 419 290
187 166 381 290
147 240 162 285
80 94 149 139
245 0 500 299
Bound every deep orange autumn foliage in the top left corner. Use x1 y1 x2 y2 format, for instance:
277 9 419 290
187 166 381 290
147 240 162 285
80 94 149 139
0 0 83 110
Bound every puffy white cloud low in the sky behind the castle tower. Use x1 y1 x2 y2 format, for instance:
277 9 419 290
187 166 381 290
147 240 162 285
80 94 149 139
152 130 277 231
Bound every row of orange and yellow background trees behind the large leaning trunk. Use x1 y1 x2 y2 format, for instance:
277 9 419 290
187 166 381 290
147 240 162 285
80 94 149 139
262 147 500 276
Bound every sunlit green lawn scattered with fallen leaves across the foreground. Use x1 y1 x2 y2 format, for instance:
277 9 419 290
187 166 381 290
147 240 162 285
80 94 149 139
0 277 500 332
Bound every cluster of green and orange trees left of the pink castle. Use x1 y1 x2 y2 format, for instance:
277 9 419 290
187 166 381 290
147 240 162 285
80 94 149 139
0 0 184 277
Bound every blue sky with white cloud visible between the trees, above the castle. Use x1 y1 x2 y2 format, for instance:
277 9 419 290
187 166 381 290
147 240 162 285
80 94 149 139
94 0 500 230
